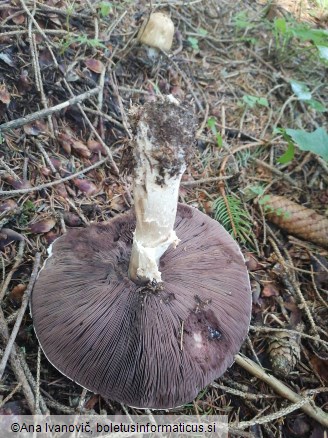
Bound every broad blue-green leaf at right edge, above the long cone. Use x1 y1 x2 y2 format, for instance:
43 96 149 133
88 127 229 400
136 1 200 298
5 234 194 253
280 128 328 161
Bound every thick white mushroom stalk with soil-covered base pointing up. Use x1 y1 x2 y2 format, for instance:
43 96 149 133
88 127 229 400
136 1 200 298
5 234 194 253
129 96 193 283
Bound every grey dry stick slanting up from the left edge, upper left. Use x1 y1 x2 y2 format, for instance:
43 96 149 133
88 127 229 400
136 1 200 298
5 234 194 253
0 87 100 132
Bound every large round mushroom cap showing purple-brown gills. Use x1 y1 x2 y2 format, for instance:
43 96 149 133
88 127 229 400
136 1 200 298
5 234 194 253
32 204 251 409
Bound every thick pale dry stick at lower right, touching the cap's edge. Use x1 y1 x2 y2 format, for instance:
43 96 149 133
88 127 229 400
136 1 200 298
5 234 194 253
235 354 328 427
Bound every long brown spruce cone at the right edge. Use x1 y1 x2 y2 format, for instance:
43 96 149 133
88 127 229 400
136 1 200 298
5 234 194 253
260 195 328 248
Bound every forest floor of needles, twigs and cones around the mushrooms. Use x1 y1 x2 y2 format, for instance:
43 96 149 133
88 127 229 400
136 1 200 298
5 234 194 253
0 0 328 438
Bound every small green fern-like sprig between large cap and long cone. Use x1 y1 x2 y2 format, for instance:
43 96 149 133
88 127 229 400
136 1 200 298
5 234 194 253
213 194 252 242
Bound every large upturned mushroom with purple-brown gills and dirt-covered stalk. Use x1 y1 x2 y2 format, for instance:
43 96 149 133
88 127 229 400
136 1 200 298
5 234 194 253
31 97 251 409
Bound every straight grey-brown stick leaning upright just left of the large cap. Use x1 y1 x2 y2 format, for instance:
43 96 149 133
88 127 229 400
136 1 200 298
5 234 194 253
0 253 41 379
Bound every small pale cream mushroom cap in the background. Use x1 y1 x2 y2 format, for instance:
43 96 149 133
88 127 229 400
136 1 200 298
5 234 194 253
137 12 174 52
